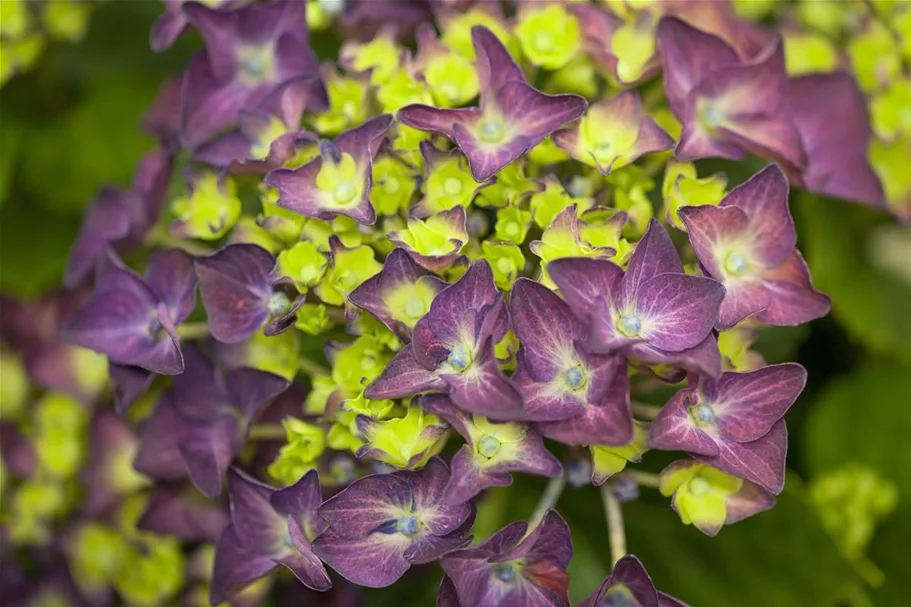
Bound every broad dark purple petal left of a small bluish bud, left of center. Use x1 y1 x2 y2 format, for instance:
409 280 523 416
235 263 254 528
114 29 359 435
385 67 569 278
196 244 275 343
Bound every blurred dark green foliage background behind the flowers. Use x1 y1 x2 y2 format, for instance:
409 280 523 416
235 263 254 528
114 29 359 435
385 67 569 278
0 1 911 607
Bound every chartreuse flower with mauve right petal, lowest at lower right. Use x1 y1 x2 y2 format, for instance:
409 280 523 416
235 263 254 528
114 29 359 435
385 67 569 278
658 460 775 536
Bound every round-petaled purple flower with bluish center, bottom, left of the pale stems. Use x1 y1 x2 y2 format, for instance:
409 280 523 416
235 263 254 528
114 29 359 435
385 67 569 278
313 458 474 588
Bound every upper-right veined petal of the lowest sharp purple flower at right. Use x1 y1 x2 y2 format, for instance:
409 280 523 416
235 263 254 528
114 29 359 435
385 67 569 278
703 363 807 443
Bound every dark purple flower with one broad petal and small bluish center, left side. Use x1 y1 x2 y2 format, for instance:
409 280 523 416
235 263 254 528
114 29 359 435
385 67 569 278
196 243 304 344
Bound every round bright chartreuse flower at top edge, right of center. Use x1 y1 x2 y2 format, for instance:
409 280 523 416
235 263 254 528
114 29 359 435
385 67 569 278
514 4 582 70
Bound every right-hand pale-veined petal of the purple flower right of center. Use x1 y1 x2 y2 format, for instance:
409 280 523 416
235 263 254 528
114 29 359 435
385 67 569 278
636 274 725 352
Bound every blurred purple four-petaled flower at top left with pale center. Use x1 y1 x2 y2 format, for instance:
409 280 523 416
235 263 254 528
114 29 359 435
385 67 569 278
181 0 328 147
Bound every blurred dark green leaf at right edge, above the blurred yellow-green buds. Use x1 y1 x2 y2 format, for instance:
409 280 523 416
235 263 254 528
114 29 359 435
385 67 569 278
802 364 911 500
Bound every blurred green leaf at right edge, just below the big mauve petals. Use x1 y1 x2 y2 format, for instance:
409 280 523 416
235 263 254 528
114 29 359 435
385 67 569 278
794 197 911 361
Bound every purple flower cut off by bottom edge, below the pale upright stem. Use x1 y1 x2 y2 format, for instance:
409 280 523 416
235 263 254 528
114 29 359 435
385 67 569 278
578 554 687 607
